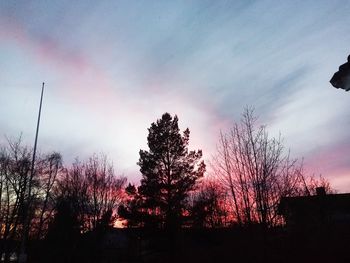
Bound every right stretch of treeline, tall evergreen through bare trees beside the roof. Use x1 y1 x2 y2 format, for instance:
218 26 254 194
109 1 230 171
119 108 331 229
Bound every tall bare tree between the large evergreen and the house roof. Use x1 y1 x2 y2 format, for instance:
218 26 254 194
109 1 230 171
213 108 304 226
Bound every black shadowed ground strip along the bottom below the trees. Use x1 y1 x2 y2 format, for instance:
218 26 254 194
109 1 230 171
4 227 350 263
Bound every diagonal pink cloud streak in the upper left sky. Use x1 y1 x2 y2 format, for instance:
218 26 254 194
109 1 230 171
0 17 119 106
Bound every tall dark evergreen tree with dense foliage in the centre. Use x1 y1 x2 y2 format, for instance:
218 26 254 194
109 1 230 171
138 113 205 229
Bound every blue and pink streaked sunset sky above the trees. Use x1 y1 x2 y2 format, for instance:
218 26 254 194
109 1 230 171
0 0 350 192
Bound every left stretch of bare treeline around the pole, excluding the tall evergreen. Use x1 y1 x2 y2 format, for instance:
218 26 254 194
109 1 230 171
0 139 126 262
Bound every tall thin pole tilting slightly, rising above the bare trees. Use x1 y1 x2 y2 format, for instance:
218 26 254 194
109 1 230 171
18 82 45 263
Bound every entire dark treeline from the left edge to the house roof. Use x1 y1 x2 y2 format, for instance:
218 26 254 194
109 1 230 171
0 108 331 261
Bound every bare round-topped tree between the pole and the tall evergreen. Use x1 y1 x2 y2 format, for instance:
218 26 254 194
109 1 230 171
58 155 126 231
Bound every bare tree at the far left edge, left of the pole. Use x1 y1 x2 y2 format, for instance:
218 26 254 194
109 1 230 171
0 137 33 262
